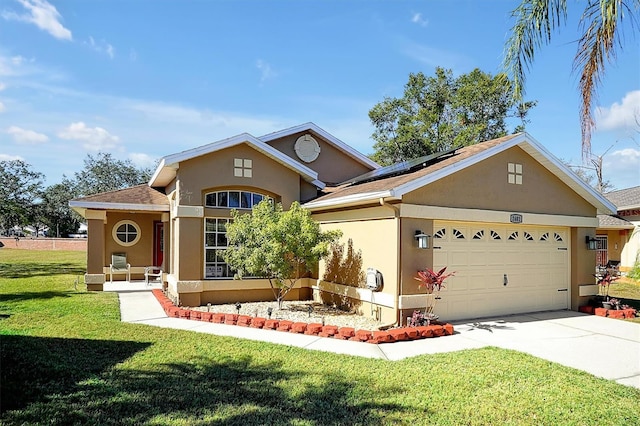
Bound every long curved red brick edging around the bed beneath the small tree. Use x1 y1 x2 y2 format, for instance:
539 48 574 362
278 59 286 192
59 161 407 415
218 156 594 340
151 289 453 343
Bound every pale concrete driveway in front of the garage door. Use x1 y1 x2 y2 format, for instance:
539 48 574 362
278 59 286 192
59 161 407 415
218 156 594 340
380 311 640 388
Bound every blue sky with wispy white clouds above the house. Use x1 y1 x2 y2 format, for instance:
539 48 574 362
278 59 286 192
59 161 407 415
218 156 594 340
0 0 640 189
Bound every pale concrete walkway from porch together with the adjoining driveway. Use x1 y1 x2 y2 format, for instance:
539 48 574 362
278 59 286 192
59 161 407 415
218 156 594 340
115 285 640 388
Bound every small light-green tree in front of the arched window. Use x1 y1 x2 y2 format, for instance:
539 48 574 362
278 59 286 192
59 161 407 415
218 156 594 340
220 200 342 309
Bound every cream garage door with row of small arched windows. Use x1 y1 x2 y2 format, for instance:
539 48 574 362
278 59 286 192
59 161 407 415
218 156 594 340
432 221 570 320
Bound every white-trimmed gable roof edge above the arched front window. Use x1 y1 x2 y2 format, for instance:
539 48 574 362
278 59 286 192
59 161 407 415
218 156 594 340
149 133 325 189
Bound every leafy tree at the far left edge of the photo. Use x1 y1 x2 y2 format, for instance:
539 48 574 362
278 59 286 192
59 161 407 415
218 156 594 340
0 160 44 233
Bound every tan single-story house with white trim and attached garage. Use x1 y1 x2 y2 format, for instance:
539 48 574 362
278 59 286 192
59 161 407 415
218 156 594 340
70 123 616 324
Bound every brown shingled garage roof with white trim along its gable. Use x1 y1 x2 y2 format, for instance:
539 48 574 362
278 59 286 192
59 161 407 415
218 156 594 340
305 133 616 214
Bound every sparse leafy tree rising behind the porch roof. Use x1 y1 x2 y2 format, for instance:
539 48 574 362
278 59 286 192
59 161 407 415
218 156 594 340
73 152 153 196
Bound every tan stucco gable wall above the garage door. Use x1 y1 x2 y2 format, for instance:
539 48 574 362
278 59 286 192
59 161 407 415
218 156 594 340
402 146 596 217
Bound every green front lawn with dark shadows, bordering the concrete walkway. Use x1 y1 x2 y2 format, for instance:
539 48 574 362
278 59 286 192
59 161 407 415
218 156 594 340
0 248 640 425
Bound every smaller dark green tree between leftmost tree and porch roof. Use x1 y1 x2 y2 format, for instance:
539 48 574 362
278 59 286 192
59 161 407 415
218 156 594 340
42 177 80 237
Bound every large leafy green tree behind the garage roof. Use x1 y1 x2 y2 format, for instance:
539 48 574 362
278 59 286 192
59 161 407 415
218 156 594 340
369 67 535 165
